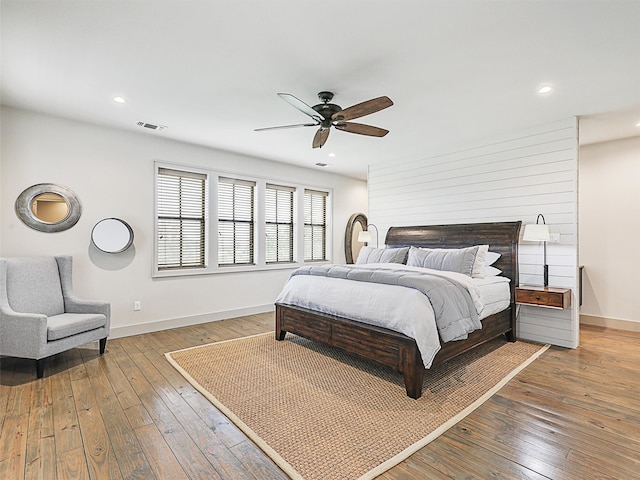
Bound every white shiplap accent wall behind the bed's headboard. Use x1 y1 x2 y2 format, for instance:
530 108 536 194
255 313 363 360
368 118 579 348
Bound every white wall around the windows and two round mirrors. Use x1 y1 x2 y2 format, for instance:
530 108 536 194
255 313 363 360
0 108 367 336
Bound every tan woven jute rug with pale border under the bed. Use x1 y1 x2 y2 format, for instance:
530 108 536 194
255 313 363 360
166 333 547 480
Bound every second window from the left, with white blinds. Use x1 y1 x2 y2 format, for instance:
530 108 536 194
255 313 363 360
218 177 256 265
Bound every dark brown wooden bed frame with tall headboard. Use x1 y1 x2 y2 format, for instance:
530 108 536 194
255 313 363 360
275 221 522 399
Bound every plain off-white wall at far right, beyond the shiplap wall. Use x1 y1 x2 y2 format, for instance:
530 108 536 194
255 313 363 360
579 136 640 331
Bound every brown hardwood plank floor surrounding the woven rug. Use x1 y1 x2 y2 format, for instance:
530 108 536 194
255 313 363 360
0 313 640 480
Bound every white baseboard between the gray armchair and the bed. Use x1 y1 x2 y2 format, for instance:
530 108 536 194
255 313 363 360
109 304 275 338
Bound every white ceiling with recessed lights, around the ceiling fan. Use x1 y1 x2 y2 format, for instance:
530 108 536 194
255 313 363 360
0 0 640 178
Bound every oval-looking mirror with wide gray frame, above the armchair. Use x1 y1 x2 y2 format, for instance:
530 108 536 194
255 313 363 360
15 183 81 232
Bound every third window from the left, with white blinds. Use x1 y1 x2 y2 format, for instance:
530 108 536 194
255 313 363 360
265 184 295 263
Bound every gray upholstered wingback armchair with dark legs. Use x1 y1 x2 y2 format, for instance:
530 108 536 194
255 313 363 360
0 256 111 378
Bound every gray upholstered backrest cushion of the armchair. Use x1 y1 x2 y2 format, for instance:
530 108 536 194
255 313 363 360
6 257 64 317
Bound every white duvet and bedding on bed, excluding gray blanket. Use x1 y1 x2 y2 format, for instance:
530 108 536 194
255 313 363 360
276 263 509 368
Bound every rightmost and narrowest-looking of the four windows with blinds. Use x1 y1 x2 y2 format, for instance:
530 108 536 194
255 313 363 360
304 190 327 261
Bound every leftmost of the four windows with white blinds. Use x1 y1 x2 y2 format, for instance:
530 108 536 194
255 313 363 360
156 168 207 270
